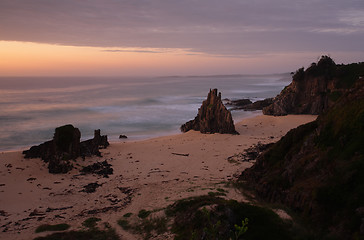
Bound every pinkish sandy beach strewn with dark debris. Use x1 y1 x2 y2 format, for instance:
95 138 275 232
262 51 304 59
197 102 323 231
0 115 316 240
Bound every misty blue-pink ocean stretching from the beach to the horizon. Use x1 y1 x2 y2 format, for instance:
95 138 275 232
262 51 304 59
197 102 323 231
0 73 291 151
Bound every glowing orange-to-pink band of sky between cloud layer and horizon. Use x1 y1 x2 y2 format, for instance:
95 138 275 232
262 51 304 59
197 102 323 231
0 41 362 76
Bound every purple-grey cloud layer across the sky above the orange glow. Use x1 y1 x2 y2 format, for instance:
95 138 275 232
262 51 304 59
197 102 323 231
0 0 364 56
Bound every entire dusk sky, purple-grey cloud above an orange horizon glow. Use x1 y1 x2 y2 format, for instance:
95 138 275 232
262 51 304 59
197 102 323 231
0 0 364 76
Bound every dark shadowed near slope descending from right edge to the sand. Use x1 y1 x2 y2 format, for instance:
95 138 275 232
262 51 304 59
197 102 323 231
241 79 364 239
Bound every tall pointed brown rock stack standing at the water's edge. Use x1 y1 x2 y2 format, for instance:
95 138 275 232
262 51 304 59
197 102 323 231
181 89 239 134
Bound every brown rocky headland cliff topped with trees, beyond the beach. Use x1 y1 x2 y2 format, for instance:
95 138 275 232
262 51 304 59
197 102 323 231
263 56 364 116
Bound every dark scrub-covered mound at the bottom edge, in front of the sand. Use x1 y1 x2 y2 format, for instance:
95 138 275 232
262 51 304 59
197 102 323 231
118 194 307 240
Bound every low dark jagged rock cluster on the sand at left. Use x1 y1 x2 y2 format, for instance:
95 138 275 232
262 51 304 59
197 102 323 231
23 125 109 173
